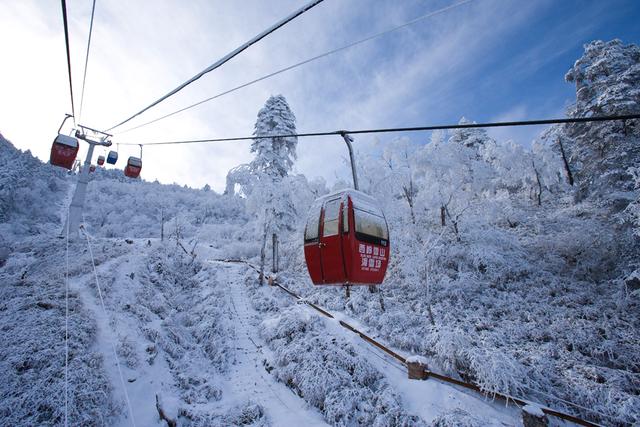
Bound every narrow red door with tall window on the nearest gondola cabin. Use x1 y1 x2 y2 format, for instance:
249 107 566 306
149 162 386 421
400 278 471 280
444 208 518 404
319 198 347 284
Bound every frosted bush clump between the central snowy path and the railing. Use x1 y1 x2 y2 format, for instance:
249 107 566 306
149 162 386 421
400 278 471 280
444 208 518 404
261 306 424 426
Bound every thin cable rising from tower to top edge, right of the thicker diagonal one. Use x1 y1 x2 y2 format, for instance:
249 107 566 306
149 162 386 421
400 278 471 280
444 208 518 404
116 0 473 134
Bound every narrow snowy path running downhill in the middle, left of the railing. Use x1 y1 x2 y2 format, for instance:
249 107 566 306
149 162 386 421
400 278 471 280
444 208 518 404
220 265 327 426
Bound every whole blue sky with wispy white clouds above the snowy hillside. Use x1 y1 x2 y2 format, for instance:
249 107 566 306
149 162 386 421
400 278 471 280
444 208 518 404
0 0 640 191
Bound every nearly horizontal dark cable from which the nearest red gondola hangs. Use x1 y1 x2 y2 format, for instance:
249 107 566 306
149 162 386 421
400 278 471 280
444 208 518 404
119 114 640 145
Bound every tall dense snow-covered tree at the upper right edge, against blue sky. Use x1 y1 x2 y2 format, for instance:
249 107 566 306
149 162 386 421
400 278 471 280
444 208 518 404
556 40 640 206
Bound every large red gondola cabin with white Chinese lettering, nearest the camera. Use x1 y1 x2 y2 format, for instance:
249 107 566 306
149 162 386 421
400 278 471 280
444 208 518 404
304 190 390 285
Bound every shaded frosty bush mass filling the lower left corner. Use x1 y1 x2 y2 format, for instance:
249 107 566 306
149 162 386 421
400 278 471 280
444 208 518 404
0 236 117 426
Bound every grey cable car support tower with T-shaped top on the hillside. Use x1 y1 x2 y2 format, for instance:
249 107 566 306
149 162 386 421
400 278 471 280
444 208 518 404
65 125 112 237
